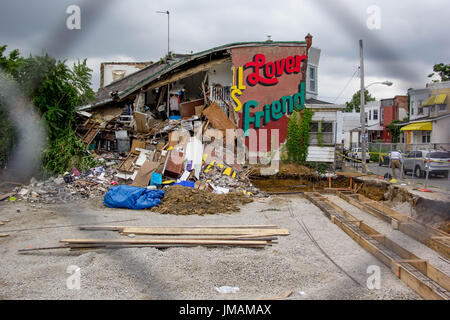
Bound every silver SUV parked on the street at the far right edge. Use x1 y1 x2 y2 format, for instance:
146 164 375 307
403 150 450 178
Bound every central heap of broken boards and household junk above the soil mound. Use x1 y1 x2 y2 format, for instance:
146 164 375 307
105 103 260 195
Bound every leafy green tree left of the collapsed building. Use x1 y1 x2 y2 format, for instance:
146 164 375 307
0 46 94 173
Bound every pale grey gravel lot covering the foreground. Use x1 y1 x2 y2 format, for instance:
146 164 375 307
0 195 418 299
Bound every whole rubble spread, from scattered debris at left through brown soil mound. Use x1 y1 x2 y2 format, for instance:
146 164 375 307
5 100 264 209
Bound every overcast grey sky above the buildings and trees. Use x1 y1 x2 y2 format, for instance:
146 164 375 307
0 0 450 103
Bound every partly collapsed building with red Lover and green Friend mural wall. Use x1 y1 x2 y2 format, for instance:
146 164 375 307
78 35 342 190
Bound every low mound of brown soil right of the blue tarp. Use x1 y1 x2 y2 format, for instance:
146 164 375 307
152 186 253 215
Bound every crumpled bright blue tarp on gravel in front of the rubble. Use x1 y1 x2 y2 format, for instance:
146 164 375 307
103 185 164 210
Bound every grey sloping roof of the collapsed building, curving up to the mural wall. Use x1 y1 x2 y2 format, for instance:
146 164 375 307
92 41 310 107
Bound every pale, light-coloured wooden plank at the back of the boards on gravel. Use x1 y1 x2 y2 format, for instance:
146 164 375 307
122 227 289 236
